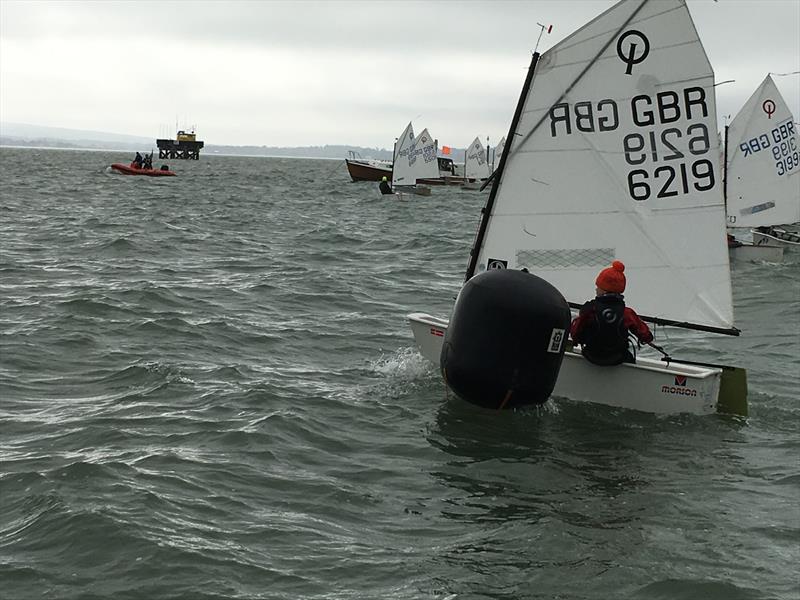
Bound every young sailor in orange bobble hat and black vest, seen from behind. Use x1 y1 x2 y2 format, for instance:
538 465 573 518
570 260 653 366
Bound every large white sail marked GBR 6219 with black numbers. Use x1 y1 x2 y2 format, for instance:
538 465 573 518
469 0 733 329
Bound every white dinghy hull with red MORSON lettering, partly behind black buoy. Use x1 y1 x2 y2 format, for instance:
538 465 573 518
408 313 746 415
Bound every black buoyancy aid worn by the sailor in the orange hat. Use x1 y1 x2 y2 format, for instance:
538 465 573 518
581 294 628 366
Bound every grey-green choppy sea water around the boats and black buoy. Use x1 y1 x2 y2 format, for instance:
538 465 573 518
0 148 800 600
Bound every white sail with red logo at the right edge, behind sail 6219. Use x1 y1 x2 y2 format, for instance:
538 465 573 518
726 75 800 227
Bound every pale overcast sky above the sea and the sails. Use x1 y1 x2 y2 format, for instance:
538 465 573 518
0 0 800 148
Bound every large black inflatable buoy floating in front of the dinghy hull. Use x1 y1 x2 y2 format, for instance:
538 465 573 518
440 269 571 409
